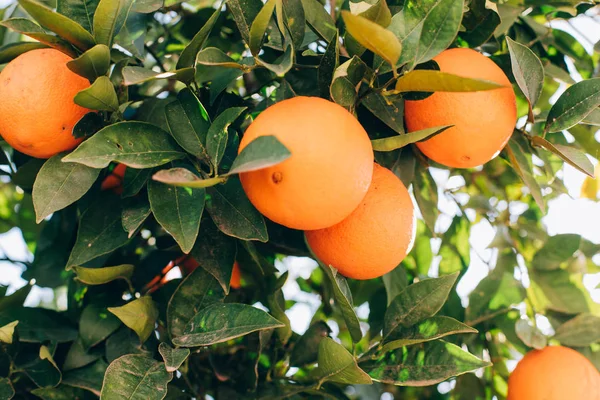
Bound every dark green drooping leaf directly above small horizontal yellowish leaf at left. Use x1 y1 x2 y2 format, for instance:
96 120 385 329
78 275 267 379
67 199 128 267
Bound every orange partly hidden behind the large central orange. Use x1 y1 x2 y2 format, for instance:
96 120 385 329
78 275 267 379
305 164 416 279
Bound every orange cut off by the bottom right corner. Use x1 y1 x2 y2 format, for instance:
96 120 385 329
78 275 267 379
507 346 600 400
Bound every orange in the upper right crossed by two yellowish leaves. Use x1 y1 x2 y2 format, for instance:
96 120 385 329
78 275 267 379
404 49 517 168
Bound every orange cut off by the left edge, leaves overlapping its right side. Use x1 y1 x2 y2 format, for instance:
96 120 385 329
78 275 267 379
0 49 90 158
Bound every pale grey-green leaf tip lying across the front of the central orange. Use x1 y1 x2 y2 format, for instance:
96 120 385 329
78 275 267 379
228 135 292 175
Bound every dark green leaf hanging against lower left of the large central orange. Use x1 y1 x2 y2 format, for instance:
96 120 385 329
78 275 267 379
206 176 269 242
